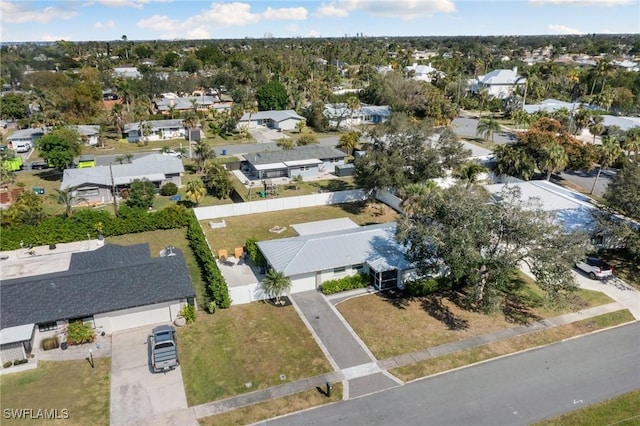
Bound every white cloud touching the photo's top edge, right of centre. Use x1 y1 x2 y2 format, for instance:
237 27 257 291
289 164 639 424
316 0 456 20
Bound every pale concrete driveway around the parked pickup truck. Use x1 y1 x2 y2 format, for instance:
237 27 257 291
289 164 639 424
111 327 198 426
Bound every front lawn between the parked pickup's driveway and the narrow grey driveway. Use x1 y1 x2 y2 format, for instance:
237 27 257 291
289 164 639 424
178 302 331 406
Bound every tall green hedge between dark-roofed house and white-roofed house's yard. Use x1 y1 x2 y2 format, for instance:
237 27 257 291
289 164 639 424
187 213 231 308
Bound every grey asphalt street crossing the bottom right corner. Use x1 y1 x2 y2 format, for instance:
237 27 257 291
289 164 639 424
266 322 640 425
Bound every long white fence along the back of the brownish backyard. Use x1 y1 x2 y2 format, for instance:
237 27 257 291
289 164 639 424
194 189 367 220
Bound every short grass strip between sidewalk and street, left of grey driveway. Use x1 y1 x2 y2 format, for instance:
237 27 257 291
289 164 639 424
199 383 342 426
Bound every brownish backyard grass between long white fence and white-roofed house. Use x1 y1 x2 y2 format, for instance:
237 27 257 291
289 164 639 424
201 202 398 254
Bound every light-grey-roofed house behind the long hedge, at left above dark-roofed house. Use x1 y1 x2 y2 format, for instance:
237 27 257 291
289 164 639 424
60 154 184 204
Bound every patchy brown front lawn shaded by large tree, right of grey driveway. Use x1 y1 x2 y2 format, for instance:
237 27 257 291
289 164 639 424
336 284 613 359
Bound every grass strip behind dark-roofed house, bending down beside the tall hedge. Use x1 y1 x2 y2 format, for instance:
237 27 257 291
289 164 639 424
106 228 207 301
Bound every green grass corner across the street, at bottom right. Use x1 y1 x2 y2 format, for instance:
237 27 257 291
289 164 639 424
536 389 640 426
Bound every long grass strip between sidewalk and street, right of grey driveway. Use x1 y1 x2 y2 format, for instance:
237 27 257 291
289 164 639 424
389 309 634 382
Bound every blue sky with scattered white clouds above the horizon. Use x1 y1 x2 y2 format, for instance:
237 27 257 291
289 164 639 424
0 0 640 42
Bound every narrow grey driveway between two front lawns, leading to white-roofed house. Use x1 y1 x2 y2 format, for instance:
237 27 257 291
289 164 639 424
289 290 375 369
